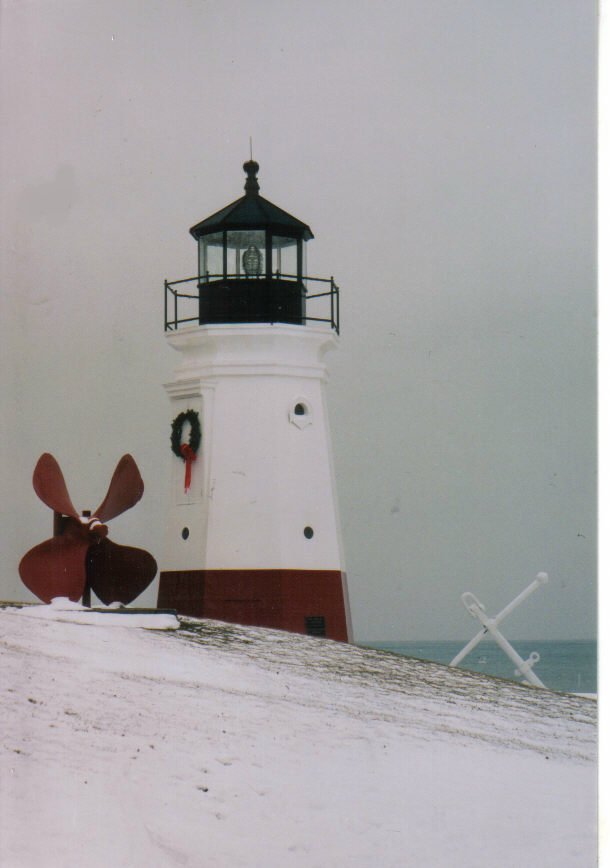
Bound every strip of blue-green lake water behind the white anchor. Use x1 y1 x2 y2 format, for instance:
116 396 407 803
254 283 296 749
360 639 597 693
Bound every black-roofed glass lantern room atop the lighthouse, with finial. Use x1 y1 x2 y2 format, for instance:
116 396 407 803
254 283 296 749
190 160 313 324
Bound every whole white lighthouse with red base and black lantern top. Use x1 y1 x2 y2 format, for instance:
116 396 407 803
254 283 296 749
158 160 351 641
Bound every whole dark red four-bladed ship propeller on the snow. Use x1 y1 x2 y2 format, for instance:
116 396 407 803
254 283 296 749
19 452 157 605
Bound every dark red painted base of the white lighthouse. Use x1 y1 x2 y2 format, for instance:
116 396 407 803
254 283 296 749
157 570 349 642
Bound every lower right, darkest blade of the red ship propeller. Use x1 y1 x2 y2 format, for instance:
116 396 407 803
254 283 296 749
87 539 157 606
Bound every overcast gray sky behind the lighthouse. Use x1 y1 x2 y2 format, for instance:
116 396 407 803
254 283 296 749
0 0 596 641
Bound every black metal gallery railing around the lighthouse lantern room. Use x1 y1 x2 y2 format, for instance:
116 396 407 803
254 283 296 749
165 273 339 334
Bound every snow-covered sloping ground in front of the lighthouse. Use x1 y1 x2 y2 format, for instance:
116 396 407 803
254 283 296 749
0 607 596 868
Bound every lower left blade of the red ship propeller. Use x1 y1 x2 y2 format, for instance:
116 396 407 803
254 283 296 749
19 536 89 603
